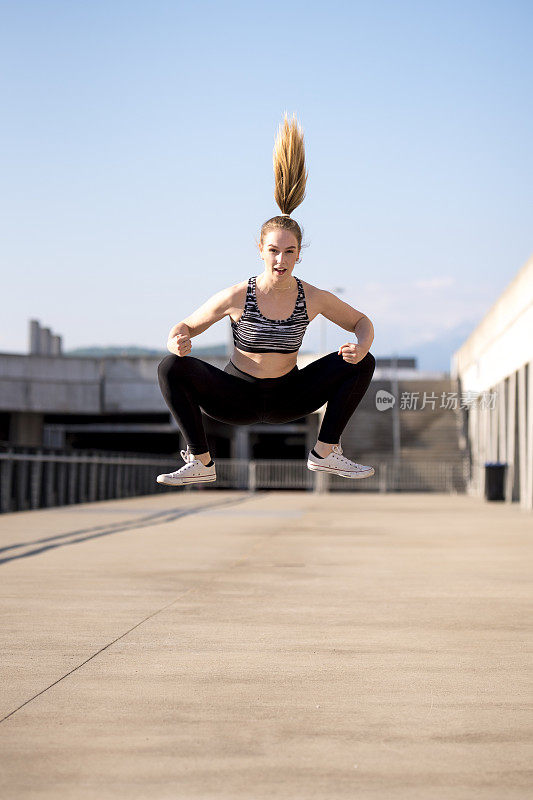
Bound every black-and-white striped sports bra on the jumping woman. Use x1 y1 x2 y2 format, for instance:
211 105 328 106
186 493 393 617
231 275 309 353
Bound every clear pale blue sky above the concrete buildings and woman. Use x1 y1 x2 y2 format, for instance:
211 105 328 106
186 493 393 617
0 0 533 368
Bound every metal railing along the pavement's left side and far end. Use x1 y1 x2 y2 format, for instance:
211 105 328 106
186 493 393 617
0 448 468 513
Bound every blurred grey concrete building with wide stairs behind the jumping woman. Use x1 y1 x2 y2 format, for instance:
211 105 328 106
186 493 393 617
0 321 465 492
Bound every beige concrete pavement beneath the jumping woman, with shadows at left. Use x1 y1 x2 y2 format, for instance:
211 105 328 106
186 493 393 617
0 490 533 800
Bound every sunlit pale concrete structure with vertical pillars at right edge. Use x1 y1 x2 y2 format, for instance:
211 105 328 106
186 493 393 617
451 257 533 511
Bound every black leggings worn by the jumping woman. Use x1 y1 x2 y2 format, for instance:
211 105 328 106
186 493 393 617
158 352 376 455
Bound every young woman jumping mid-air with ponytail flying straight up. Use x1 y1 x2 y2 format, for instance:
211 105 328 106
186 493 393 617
157 114 376 486
